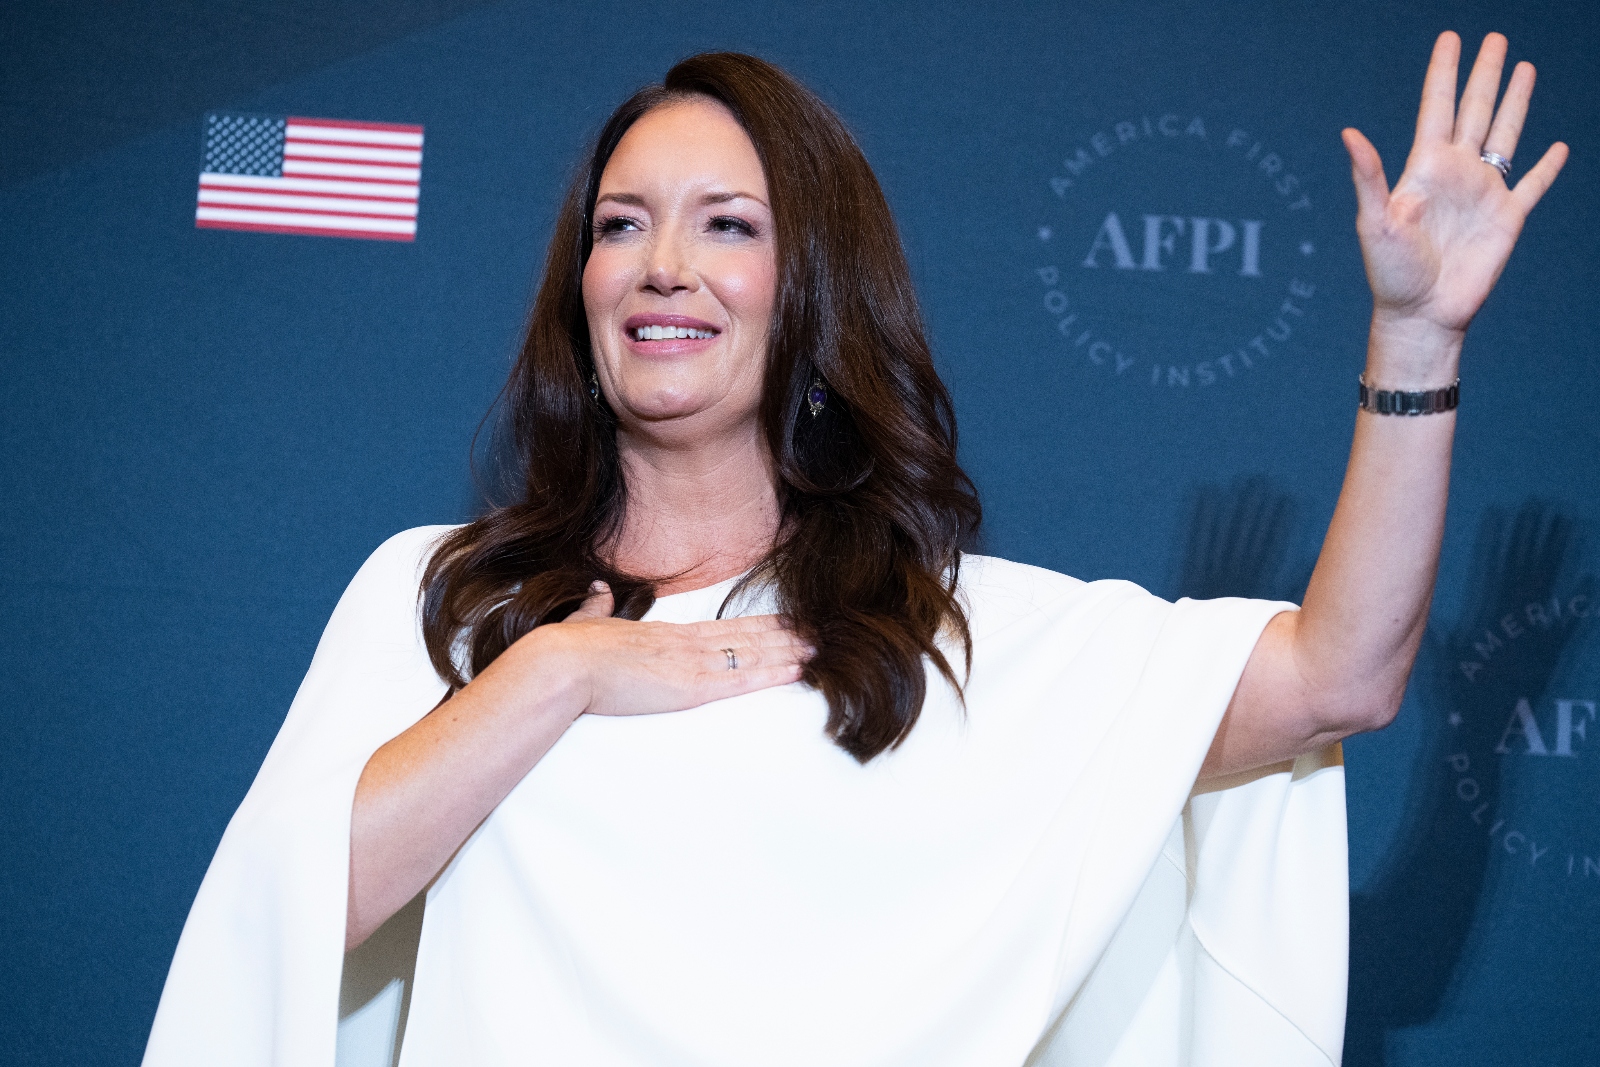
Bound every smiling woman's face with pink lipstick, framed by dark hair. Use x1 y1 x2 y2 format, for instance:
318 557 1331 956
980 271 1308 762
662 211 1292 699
584 98 778 445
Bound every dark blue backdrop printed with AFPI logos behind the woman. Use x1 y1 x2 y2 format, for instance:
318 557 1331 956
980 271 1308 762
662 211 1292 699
0 0 1600 1067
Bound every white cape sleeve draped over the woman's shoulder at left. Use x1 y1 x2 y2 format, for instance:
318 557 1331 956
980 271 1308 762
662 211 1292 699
144 526 448 1067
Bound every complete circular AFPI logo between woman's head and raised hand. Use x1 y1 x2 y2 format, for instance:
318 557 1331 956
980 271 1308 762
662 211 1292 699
1034 114 1317 389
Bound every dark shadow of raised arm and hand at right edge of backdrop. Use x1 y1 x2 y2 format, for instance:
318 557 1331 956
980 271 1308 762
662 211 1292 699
1344 501 1576 1067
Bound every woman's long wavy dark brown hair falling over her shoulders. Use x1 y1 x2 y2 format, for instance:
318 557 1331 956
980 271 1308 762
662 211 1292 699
422 53 981 761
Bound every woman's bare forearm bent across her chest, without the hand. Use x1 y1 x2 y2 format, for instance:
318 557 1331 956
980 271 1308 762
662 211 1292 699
344 632 582 950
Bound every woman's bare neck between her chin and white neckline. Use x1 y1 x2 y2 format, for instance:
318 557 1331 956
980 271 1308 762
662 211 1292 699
611 426 778 597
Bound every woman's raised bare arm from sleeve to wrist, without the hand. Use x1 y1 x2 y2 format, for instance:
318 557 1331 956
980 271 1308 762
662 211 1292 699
1202 314 1461 777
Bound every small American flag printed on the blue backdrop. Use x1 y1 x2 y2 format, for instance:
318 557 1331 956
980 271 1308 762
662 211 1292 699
195 114 422 242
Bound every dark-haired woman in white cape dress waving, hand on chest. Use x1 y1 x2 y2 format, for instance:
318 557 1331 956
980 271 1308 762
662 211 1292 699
146 34 1565 1067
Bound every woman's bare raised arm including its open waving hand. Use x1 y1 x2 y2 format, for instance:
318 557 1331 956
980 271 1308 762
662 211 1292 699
1202 34 1566 776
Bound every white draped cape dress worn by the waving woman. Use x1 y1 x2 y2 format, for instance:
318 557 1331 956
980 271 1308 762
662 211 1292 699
144 526 1347 1067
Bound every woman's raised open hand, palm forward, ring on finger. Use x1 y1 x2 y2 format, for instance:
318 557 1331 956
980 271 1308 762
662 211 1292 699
1344 32 1566 347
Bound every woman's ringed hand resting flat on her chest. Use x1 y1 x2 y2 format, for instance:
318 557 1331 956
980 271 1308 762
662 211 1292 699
518 582 816 718
